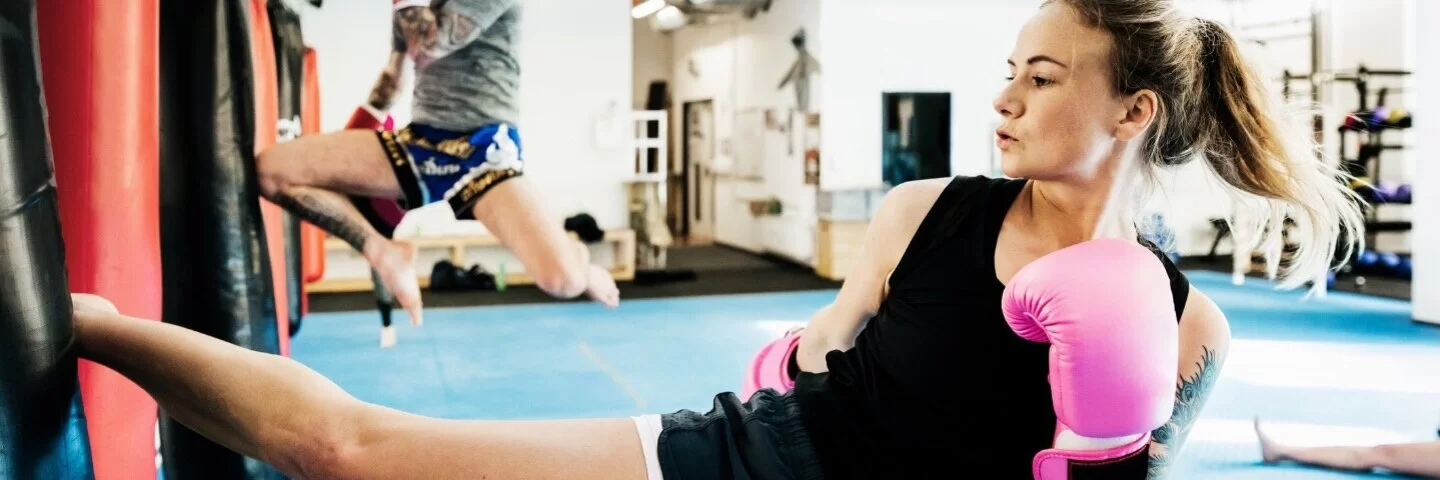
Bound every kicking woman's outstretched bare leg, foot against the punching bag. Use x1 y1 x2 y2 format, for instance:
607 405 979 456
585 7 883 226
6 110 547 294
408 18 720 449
73 295 645 480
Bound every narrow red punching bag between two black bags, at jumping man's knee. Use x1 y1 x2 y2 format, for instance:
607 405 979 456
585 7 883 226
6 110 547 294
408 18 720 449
249 0 289 356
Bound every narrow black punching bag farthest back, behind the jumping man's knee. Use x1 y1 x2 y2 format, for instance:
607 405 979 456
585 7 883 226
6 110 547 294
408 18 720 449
265 0 305 336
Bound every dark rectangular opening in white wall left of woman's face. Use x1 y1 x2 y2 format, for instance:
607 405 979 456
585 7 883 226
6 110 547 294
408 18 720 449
880 92 950 186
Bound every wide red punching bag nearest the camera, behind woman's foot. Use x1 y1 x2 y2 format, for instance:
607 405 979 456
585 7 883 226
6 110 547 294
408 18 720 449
36 0 161 480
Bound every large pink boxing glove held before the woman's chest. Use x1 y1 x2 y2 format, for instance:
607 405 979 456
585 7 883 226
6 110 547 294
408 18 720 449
1001 239 1179 480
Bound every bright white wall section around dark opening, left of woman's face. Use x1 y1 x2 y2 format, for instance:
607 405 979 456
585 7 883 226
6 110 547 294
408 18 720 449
819 0 1038 190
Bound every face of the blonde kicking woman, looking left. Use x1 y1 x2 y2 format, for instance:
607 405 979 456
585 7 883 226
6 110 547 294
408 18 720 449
995 3 1126 180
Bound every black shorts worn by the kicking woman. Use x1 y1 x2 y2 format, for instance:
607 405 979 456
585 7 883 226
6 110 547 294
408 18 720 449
642 391 824 480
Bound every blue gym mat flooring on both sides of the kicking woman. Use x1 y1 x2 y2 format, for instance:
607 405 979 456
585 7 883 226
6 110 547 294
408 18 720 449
292 271 1440 479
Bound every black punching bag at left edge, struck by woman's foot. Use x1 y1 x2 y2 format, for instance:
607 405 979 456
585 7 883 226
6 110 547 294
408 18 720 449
0 0 95 480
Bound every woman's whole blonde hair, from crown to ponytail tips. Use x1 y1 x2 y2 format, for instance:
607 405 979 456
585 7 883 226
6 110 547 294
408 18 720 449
1045 0 1364 288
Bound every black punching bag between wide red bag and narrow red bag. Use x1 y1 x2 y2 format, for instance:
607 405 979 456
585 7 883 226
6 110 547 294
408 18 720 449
160 0 282 480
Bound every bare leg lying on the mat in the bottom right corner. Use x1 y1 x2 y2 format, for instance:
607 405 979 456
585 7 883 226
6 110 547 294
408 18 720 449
1256 419 1440 479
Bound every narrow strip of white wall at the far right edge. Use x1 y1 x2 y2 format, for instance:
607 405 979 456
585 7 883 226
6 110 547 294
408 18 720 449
1410 1 1440 323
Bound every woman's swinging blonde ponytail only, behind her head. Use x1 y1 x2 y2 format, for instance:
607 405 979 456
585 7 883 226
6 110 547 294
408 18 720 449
1192 19 1364 288
